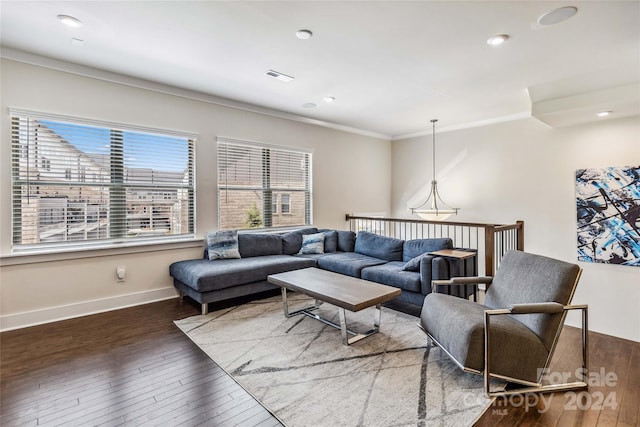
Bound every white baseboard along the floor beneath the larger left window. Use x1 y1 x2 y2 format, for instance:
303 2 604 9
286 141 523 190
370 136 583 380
0 286 178 332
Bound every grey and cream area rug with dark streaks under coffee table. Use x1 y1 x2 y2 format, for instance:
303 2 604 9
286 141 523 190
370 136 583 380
175 294 491 427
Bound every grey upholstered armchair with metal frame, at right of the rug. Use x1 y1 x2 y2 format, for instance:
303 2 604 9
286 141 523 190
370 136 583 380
419 251 588 396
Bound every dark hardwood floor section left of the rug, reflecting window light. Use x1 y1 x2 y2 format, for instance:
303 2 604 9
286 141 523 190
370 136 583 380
0 300 282 427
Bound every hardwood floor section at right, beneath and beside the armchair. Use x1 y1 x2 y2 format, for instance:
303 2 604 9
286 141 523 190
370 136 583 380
476 327 640 427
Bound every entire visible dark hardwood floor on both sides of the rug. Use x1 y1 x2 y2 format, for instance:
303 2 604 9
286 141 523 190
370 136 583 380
0 300 640 427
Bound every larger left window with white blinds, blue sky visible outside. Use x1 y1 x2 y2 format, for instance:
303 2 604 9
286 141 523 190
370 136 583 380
11 110 195 251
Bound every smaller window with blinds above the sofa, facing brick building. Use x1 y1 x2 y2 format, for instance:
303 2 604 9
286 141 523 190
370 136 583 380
218 138 311 230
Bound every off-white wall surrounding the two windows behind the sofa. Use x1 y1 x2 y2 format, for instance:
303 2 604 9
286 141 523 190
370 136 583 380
0 59 391 329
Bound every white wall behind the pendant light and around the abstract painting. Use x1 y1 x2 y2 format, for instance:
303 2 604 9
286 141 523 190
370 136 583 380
391 117 640 341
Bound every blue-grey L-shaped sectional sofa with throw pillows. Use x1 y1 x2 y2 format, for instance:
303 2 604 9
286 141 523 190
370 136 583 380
169 227 476 314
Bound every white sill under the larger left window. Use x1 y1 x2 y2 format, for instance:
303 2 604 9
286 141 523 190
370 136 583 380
0 237 203 267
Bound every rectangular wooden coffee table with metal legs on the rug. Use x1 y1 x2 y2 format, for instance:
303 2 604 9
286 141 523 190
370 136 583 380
267 267 402 345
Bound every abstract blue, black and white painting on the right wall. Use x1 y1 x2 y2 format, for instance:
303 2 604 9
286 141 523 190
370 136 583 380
576 166 640 267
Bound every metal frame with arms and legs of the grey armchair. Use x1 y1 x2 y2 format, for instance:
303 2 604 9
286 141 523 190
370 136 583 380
418 271 589 397
